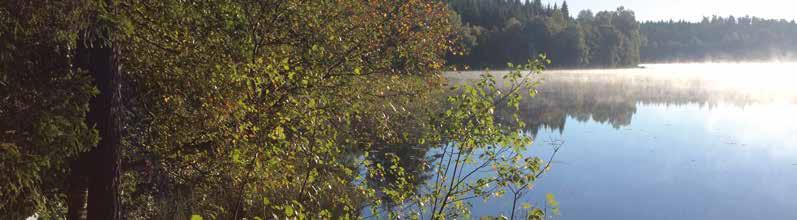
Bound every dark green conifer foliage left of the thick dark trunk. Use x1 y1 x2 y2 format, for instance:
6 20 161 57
0 1 98 219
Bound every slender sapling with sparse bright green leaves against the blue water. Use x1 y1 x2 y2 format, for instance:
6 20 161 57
418 59 547 218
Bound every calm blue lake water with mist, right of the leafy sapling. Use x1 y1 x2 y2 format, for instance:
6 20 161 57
451 64 797 219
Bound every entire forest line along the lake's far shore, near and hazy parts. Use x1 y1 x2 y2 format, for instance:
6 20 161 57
447 0 797 68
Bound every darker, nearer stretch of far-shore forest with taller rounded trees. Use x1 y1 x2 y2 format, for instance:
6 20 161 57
448 0 642 68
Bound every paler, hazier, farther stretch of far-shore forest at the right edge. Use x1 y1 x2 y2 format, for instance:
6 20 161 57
641 16 797 62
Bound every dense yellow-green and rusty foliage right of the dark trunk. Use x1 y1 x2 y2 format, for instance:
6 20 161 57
111 0 460 218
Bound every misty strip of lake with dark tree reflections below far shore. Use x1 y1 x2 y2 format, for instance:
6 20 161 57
449 64 797 134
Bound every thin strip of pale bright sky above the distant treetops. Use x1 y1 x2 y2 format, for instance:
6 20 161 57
543 0 797 21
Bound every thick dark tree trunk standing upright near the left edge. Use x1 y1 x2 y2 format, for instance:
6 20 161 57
69 28 121 220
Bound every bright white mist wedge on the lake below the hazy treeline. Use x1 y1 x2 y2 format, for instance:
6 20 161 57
556 63 797 102
